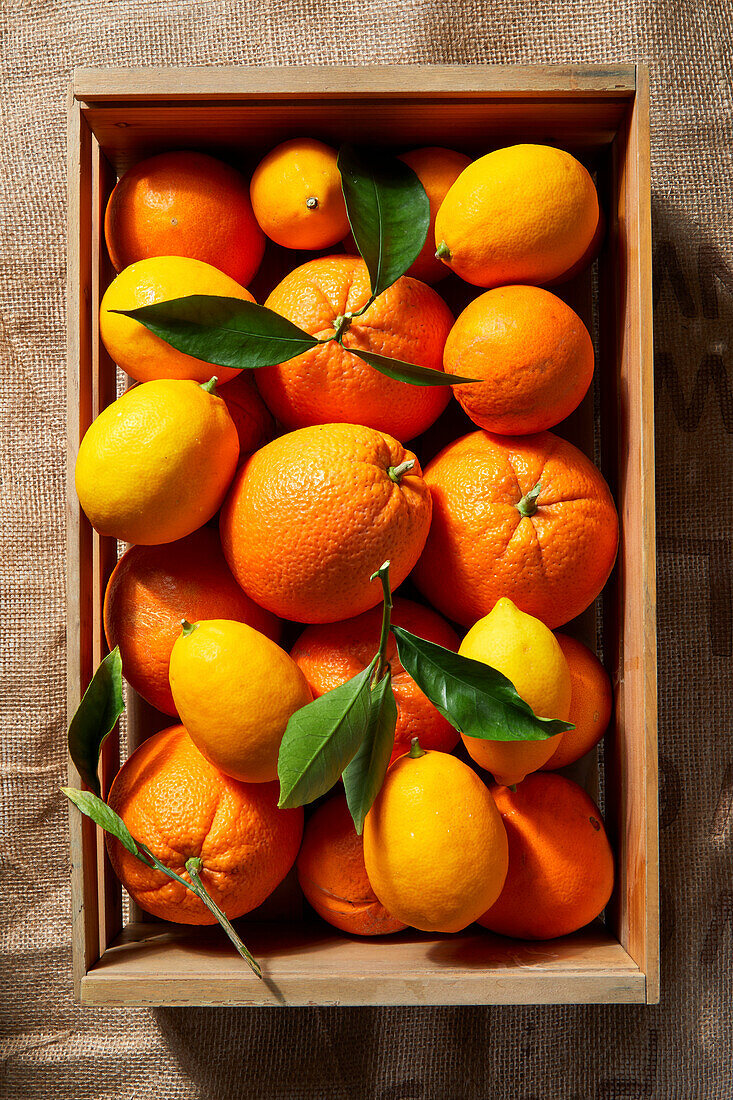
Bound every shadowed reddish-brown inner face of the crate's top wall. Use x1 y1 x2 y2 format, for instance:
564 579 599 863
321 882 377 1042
83 101 625 173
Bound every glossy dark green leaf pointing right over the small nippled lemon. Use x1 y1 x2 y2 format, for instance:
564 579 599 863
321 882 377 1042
392 626 576 741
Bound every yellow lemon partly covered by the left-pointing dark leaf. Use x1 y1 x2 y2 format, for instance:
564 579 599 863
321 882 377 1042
99 256 254 384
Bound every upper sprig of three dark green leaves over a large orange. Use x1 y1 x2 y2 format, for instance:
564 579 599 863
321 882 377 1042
107 145 475 386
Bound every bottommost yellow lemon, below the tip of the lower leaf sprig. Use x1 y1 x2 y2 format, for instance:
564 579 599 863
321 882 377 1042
364 744 508 932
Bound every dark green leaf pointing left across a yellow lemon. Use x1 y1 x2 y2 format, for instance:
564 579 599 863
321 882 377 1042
112 294 318 371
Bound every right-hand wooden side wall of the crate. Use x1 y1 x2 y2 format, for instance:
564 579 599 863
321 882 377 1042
601 67 659 1003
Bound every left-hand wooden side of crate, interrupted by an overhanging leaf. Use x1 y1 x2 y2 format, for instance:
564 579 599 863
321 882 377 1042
66 96 99 997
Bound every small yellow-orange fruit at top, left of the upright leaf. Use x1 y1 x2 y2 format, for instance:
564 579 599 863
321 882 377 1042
250 138 349 250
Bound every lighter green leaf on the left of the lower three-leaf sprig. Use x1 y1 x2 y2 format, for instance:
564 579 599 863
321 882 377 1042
277 658 376 809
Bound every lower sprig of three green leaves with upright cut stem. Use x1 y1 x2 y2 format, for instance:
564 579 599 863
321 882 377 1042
277 561 575 834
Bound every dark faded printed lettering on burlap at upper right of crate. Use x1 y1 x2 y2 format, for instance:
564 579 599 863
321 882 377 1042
654 240 733 435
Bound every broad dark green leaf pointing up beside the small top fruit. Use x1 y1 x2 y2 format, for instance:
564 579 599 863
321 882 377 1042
338 145 430 297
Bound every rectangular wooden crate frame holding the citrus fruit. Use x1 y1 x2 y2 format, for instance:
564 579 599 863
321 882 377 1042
67 65 658 1005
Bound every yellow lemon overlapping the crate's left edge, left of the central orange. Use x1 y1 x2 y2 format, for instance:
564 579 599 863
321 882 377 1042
76 378 239 546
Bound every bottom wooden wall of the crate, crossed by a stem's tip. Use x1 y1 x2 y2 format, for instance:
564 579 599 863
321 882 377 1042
81 923 644 1005
